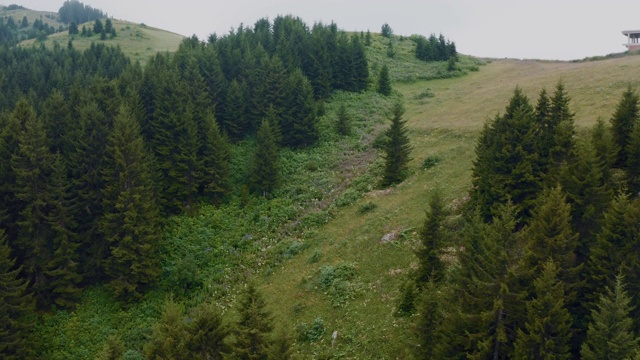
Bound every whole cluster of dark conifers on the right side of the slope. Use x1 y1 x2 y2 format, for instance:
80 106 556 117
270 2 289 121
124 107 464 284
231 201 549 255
401 83 640 359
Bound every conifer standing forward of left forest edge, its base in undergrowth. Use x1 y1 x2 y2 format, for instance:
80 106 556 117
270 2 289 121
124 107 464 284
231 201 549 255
251 120 278 197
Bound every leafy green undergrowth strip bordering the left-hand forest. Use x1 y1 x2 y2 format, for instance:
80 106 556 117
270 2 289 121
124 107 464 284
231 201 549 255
34 92 395 359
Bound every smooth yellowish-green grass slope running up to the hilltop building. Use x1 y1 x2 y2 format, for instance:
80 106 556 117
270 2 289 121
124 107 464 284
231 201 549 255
255 51 640 359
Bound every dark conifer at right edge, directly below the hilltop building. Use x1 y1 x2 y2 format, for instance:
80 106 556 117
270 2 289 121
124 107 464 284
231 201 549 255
611 86 640 168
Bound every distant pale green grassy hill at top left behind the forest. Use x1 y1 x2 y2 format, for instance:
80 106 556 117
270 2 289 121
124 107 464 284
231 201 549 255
21 20 184 64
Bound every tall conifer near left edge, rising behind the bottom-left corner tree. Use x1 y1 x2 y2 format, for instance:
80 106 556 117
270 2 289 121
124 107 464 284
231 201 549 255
11 102 52 305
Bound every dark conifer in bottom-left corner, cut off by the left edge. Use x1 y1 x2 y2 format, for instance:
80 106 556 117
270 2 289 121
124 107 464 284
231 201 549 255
0 230 34 359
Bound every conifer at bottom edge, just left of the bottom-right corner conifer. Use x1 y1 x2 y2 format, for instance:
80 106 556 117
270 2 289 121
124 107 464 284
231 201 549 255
515 260 572 359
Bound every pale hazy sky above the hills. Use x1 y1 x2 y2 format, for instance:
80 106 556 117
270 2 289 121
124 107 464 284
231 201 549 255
8 0 640 60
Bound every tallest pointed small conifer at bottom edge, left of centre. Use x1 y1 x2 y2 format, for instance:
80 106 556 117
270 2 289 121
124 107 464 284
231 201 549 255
232 284 273 360
